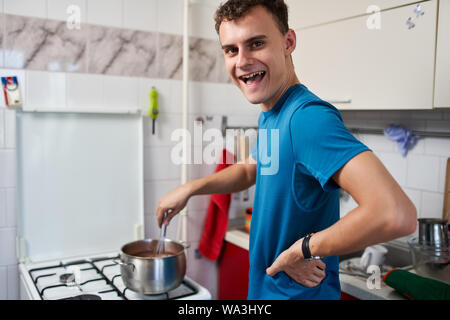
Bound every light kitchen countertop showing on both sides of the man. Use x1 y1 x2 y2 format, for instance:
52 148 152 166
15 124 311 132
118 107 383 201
225 225 413 300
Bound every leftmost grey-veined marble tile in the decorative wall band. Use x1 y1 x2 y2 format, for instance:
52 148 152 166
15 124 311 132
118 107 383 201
3 15 87 72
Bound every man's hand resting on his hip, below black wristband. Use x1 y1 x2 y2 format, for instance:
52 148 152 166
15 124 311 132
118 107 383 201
266 239 326 288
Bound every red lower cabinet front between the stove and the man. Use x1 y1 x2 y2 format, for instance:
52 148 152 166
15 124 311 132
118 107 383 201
218 241 250 300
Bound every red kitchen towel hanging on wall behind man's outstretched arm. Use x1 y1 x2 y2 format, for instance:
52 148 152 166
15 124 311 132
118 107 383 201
198 149 236 261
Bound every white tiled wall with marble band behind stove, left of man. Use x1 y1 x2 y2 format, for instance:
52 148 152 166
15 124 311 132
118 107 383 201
0 0 259 299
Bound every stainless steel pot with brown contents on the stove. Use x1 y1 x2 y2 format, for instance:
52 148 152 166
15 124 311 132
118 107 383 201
116 239 188 294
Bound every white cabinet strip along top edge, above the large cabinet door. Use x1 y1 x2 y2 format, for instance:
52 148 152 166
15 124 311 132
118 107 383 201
286 0 428 29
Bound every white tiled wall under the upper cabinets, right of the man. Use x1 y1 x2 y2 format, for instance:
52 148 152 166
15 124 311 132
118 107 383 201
341 109 450 239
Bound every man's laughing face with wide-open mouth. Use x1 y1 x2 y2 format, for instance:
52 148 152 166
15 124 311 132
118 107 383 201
219 6 298 111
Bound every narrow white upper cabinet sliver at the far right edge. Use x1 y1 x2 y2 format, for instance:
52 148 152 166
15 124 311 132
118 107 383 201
434 0 450 108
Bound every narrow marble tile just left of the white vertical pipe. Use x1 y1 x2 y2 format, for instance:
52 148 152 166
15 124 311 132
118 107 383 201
157 33 183 80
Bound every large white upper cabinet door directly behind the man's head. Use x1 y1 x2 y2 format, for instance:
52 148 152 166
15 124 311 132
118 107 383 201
292 0 437 110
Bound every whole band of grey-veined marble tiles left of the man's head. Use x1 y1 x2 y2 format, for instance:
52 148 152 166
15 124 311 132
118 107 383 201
0 14 231 83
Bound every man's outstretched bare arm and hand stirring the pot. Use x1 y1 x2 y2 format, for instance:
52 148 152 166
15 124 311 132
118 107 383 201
156 156 256 226
